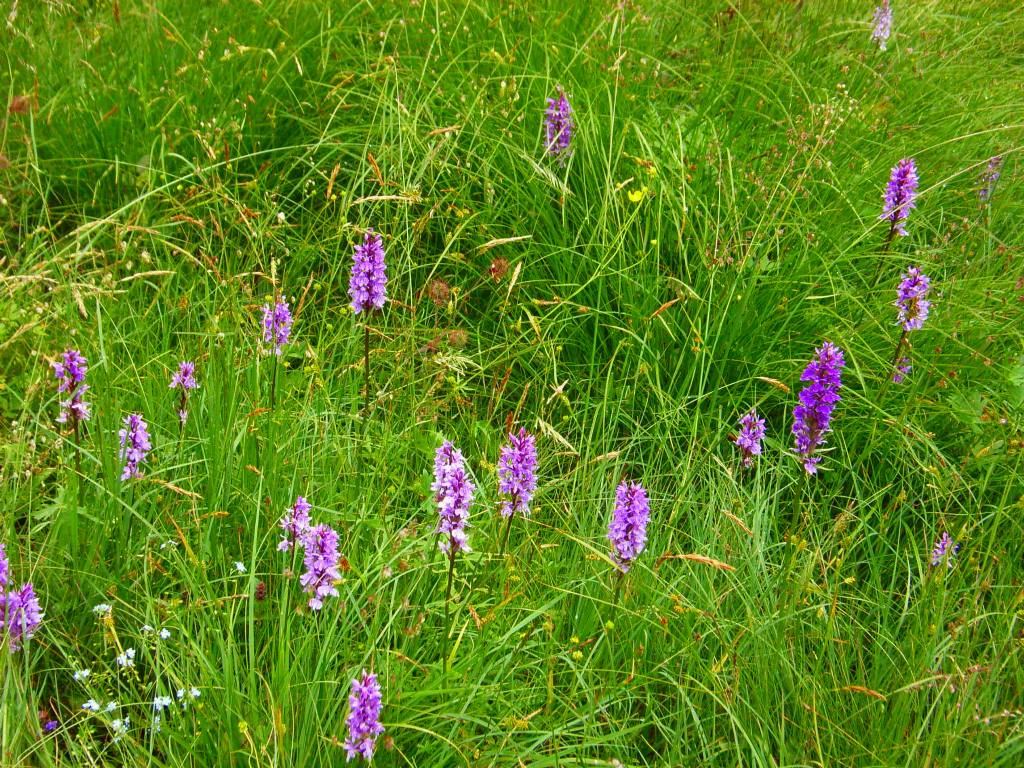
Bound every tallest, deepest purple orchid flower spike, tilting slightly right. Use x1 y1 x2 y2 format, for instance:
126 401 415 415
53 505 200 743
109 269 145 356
793 341 846 475
